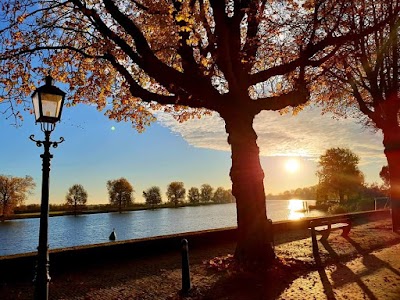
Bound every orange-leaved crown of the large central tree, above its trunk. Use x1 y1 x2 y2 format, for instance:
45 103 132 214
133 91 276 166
0 0 382 130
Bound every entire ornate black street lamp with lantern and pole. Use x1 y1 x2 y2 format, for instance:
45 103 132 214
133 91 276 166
29 76 65 300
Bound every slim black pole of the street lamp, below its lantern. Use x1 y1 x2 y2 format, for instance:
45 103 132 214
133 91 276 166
29 131 64 300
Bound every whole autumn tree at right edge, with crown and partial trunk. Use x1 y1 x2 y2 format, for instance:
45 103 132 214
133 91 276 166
315 0 400 230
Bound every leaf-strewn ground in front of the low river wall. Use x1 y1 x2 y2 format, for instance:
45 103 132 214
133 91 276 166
0 212 400 300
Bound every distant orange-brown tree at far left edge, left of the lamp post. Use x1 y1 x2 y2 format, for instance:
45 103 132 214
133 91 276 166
0 175 36 221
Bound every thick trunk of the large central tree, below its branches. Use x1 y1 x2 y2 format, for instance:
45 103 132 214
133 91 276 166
223 112 275 264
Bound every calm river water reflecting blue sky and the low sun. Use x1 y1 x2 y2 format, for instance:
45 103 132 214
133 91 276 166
0 200 324 256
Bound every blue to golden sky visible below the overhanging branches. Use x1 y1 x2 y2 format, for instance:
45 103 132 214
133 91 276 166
0 97 387 204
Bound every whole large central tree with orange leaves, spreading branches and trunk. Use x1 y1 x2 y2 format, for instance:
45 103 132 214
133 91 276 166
0 0 391 262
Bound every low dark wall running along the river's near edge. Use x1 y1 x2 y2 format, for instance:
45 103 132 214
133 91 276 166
0 210 390 281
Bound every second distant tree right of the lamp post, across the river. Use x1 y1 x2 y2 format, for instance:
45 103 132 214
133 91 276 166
107 178 134 213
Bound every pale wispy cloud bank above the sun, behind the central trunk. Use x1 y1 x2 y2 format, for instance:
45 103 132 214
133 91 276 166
157 107 385 163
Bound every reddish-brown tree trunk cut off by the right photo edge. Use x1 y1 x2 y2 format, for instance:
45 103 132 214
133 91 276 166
382 126 400 230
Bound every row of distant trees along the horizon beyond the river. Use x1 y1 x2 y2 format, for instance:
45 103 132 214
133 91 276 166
0 148 390 220
